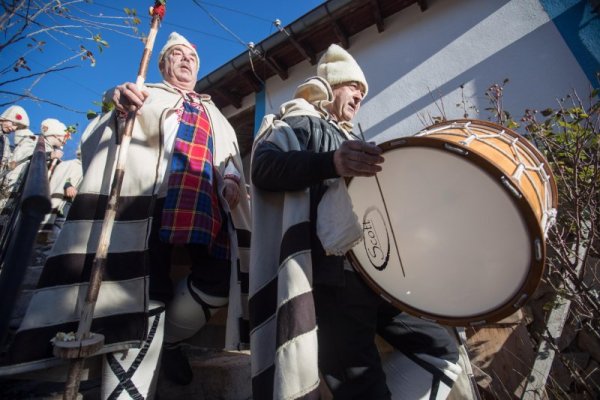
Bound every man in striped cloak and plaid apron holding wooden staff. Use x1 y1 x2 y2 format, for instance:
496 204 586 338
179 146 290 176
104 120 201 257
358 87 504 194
11 32 250 398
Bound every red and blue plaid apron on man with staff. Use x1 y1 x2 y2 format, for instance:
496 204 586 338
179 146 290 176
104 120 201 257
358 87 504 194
160 101 229 259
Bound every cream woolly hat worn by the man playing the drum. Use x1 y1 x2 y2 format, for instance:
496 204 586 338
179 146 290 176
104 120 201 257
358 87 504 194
317 44 369 96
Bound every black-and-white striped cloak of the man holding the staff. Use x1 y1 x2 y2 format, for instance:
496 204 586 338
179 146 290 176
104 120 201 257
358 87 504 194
4 84 250 370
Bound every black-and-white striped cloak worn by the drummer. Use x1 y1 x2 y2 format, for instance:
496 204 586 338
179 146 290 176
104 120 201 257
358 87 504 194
249 99 330 400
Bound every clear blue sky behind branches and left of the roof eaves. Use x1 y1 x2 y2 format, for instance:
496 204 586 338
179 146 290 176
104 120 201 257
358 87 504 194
0 0 323 159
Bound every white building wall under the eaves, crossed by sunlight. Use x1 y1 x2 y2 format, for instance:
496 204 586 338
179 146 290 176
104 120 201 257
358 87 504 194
229 0 590 142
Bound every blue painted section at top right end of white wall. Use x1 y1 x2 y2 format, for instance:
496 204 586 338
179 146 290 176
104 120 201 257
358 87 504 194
540 0 600 87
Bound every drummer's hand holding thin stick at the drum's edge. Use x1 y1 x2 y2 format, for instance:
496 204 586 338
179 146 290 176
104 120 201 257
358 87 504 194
333 140 384 177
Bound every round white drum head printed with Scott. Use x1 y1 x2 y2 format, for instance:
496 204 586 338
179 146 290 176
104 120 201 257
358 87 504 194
349 139 535 325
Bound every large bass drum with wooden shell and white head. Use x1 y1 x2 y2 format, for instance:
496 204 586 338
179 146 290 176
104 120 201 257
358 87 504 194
348 120 557 326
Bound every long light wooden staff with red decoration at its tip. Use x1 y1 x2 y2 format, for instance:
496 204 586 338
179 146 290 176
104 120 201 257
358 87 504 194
54 0 166 400
